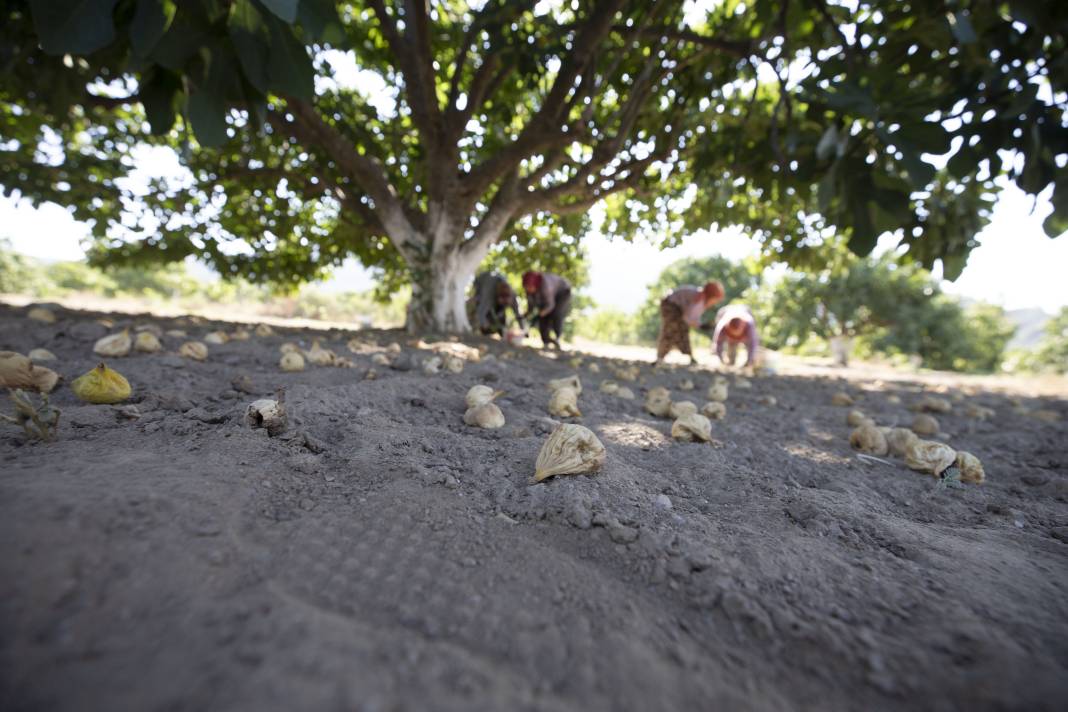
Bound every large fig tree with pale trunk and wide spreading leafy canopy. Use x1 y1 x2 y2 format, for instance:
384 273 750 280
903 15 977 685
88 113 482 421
0 0 1068 330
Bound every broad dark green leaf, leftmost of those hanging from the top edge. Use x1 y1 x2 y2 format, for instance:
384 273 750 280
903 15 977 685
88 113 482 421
30 0 119 54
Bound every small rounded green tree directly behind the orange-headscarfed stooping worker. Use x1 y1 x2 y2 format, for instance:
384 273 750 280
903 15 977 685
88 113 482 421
638 255 760 343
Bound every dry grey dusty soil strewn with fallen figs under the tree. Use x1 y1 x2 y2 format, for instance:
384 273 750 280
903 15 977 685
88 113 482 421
0 306 1068 711
